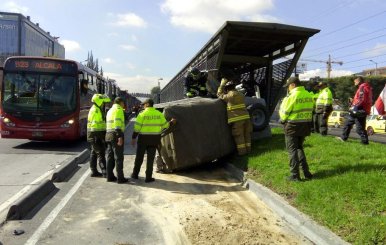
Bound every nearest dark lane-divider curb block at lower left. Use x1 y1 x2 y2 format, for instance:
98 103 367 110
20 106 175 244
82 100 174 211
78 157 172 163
6 180 57 220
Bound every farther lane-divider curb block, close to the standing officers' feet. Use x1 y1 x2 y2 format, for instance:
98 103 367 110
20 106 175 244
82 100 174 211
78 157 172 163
51 149 90 182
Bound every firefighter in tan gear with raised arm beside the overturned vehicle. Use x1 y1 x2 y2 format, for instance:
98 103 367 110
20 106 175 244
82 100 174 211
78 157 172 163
217 78 252 156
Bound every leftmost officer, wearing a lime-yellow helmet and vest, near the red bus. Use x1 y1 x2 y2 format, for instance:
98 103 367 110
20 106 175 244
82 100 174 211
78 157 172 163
87 94 110 177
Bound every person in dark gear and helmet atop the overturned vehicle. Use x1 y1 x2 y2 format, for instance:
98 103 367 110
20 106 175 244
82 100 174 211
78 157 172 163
184 67 208 98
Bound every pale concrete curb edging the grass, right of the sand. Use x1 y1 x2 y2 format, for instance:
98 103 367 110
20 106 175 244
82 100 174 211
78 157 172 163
225 164 349 245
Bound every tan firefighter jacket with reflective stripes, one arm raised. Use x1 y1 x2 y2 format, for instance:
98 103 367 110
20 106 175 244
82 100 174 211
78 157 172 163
217 79 250 124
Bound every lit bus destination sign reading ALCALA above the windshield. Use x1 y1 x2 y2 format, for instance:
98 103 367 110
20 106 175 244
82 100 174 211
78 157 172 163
4 59 77 74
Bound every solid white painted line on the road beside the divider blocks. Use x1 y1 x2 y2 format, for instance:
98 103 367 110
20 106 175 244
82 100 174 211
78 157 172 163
25 169 91 245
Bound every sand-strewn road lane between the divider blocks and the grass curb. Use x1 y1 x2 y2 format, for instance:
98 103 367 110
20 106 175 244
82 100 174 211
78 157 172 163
0 120 312 245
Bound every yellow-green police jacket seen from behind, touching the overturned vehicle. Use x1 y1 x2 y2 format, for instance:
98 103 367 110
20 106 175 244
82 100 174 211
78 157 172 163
134 107 169 135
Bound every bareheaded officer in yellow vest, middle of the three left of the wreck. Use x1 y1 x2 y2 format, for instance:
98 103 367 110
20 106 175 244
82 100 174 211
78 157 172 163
106 97 128 184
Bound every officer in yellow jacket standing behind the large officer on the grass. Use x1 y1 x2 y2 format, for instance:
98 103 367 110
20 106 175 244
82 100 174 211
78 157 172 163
315 82 332 136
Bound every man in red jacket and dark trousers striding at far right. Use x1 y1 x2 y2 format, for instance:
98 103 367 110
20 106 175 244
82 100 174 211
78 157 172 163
338 77 373 145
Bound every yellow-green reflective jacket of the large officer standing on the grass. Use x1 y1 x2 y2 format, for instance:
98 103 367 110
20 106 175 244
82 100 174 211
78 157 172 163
279 86 314 123
